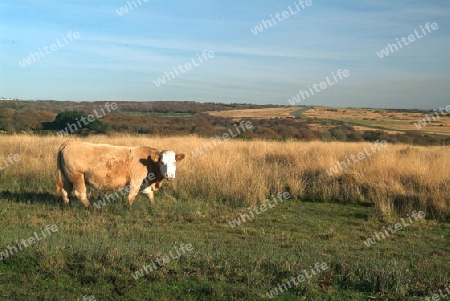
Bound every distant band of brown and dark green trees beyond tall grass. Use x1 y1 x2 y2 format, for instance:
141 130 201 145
0 100 450 145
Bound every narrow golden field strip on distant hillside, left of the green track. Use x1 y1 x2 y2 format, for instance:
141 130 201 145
208 107 299 121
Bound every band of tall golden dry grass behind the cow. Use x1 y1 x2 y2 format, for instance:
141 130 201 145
0 135 450 219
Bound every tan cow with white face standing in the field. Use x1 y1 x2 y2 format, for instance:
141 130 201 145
56 140 185 210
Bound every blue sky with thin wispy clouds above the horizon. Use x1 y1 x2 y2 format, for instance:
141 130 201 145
0 0 450 109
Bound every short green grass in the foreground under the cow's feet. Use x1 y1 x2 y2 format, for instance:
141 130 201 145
0 186 450 300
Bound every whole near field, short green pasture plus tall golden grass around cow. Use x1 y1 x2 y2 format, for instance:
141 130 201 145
0 135 450 300
